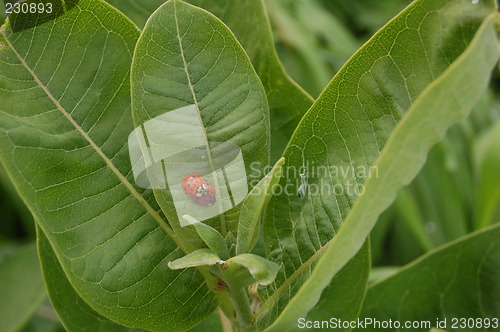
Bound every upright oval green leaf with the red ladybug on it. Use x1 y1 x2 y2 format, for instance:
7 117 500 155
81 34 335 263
131 0 270 246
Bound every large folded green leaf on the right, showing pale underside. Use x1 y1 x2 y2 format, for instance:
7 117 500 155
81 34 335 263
258 0 499 330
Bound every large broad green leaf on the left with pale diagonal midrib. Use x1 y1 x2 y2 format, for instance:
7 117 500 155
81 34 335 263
0 0 217 330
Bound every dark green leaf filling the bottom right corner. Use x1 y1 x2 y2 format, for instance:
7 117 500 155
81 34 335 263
361 224 500 330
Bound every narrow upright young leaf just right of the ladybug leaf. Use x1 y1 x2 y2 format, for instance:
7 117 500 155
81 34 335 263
236 158 285 255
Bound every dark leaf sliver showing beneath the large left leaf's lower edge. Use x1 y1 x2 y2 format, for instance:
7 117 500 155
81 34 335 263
37 227 137 332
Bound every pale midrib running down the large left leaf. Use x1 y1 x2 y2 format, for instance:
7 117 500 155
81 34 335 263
0 29 187 252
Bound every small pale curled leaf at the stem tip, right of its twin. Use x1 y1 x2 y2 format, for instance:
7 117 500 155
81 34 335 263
226 254 279 285
